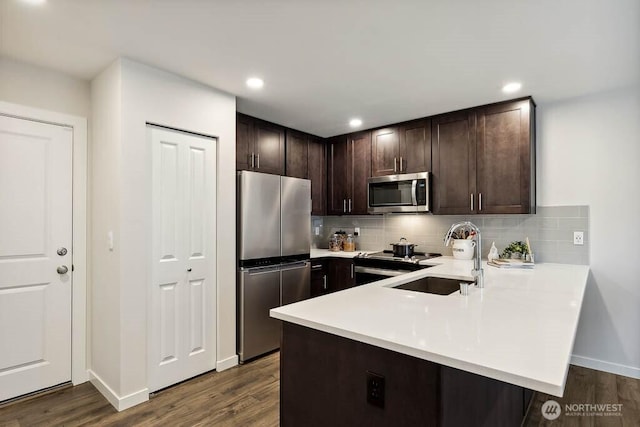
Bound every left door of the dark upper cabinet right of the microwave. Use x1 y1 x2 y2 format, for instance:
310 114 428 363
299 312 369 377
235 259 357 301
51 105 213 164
431 111 477 214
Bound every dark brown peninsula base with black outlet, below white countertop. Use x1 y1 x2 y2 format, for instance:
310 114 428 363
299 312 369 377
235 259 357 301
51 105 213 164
280 322 531 427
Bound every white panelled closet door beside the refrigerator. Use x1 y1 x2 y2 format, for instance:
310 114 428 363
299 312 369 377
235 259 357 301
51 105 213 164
148 126 217 391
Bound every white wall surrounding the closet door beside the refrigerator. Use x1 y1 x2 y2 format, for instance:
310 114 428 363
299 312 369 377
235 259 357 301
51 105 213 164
93 59 237 409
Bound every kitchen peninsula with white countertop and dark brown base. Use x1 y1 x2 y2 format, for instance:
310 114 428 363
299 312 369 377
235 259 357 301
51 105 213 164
271 257 589 427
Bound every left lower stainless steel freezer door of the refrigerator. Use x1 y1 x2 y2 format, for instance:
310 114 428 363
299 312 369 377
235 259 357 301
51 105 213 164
237 267 281 362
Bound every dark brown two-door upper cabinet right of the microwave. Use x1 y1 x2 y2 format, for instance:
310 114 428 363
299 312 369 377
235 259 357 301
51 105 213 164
431 98 535 214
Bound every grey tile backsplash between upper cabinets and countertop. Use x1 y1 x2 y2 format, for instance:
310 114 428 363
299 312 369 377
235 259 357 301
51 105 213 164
311 206 589 264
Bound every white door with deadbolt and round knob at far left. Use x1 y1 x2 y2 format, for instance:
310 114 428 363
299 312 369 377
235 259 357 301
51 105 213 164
0 115 72 401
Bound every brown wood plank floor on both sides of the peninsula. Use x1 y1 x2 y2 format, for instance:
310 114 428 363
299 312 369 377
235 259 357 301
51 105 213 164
0 352 640 427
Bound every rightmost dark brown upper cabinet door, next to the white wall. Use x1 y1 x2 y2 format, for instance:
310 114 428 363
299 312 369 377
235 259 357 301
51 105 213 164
477 100 535 214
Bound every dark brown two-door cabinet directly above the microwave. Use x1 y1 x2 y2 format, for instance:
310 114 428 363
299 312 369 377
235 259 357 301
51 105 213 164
371 119 431 176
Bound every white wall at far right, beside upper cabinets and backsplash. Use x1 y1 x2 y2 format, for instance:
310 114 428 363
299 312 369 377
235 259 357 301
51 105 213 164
537 87 640 377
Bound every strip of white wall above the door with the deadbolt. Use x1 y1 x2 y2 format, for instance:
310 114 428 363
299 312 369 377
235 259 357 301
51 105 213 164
0 57 91 117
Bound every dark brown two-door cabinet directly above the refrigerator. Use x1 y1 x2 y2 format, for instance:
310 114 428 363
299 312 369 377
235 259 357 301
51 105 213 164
236 113 284 175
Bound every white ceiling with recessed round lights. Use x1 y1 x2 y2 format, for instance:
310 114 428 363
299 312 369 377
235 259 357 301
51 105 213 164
0 0 640 136
